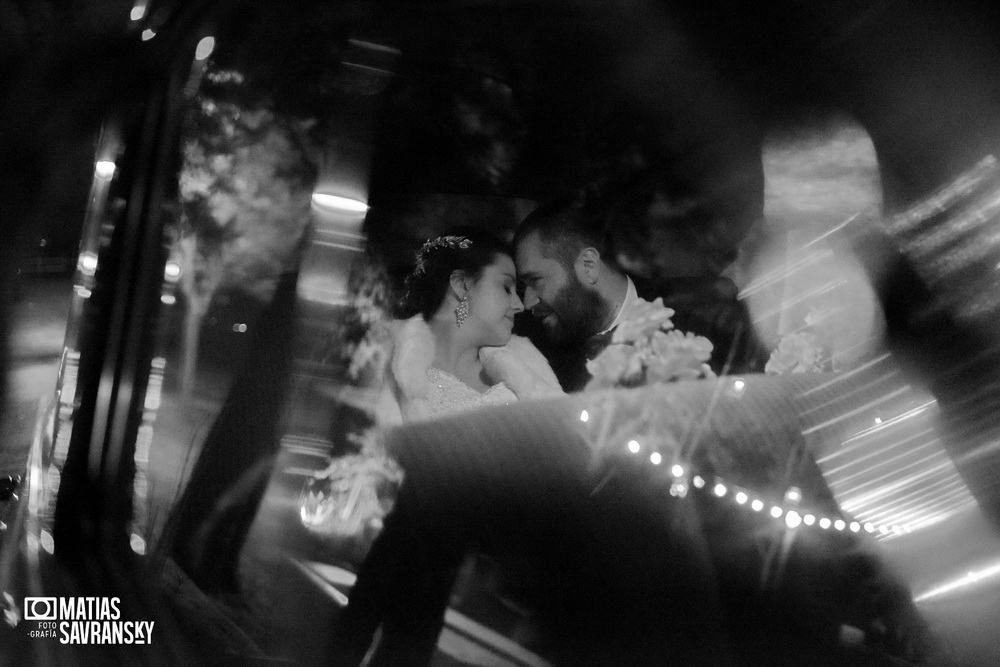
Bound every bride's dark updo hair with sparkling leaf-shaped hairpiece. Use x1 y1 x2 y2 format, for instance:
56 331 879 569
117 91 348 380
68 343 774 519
402 225 513 320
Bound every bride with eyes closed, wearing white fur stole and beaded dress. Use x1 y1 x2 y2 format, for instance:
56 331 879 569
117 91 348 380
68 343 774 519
375 227 563 425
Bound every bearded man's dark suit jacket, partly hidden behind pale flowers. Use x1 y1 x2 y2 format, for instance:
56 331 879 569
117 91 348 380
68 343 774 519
515 276 769 392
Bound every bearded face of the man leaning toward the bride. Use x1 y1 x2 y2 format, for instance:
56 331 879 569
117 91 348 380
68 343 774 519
516 233 605 343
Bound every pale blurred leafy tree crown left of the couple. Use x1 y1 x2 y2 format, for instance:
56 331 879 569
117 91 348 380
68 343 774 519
177 85 315 299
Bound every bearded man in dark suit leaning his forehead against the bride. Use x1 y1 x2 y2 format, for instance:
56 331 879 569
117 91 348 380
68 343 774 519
514 196 767 391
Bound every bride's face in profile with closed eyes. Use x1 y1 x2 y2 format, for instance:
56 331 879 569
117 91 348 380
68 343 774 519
468 255 524 345
